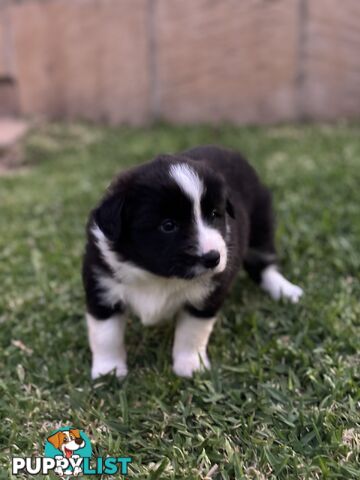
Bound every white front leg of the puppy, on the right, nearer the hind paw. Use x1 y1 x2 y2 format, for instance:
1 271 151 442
173 312 216 377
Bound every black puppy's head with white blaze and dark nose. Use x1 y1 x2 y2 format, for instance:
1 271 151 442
94 156 234 279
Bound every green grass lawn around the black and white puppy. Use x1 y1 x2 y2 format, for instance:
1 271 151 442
0 124 360 480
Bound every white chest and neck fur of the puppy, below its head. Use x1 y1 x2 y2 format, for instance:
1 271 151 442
92 226 213 325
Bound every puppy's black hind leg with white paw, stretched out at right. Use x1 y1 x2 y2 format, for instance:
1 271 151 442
244 187 303 303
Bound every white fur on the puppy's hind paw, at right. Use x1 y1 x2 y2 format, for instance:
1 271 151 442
261 265 304 303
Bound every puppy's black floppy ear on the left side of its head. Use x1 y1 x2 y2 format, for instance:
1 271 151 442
94 195 124 241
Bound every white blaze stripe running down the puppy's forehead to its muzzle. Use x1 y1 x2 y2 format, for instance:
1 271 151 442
170 163 227 273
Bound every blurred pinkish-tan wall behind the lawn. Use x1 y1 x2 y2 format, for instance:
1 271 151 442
0 0 360 124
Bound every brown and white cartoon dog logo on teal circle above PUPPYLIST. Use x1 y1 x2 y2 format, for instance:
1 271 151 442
45 427 92 476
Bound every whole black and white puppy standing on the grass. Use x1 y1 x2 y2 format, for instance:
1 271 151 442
83 146 302 378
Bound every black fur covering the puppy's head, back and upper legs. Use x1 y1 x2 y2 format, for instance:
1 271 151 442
83 146 276 319
